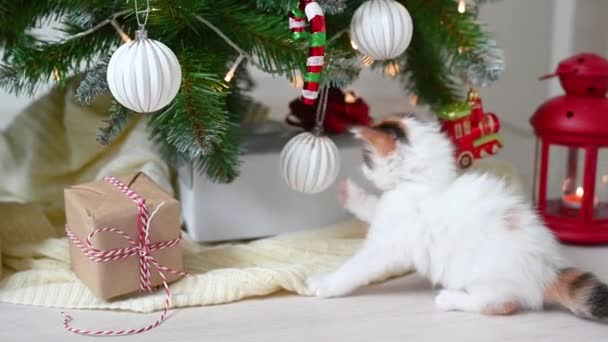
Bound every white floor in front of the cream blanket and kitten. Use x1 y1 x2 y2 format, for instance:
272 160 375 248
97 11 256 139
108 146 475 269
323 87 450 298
0 247 608 342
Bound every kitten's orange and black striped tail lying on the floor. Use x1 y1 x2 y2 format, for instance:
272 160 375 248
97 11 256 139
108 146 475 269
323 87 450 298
544 268 608 320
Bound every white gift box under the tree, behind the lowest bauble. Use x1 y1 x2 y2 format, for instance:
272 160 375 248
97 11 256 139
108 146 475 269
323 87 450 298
178 124 363 241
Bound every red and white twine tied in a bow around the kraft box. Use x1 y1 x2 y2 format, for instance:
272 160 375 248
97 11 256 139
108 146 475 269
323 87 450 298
62 177 188 336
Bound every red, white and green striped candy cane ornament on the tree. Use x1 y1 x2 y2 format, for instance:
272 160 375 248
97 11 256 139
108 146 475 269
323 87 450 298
289 0 327 105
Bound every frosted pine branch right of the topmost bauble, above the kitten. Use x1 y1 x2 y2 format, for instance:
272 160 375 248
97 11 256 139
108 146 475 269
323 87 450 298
396 0 504 107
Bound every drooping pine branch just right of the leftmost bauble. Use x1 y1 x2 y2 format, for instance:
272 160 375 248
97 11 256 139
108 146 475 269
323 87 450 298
148 50 239 182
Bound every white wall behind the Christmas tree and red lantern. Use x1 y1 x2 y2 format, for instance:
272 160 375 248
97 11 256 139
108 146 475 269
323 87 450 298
0 0 608 192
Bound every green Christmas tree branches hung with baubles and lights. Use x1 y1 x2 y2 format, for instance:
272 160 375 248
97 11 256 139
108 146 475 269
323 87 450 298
0 0 503 182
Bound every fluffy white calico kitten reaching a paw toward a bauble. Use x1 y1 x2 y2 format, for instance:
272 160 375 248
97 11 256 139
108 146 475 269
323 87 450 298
307 117 608 319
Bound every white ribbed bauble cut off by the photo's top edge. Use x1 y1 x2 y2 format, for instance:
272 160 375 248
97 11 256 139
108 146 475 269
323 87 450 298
350 0 413 61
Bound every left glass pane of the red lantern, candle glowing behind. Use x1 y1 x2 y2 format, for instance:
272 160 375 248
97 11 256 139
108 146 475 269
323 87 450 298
546 145 585 218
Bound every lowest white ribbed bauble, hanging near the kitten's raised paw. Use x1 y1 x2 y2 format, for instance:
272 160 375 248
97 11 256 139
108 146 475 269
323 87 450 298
280 132 340 194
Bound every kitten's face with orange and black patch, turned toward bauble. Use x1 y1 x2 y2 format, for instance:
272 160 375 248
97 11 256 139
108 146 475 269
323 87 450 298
354 118 409 190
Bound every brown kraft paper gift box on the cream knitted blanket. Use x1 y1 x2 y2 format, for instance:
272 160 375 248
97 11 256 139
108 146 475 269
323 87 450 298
64 173 182 299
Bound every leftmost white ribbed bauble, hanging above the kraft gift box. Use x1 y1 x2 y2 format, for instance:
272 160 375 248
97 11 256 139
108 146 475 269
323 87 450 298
107 31 182 113
